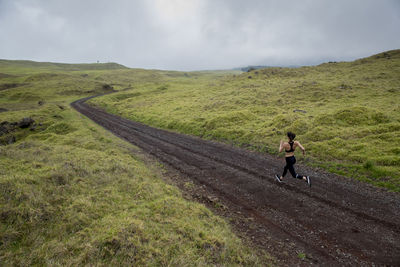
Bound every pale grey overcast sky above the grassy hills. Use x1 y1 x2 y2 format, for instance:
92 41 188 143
0 0 400 70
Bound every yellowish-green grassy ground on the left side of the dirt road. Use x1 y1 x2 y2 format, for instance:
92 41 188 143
0 61 271 266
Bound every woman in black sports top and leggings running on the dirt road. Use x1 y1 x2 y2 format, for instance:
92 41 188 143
275 132 311 187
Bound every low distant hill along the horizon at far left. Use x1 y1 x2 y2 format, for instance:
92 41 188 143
0 59 127 70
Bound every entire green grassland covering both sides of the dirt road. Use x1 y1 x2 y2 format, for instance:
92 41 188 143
0 50 400 266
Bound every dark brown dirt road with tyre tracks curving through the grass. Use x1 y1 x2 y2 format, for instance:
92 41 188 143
71 97 400 266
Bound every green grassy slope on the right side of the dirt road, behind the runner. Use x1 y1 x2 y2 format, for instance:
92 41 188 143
91 50 400 191
